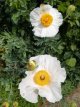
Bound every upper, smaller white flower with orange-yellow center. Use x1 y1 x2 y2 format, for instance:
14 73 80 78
30 4 63 37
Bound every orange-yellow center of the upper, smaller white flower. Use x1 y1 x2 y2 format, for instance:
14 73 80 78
41 13 53 27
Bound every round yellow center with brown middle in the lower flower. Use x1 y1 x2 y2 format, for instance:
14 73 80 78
33 70 51 86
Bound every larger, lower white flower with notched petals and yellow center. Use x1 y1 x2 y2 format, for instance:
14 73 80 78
19 55 66 103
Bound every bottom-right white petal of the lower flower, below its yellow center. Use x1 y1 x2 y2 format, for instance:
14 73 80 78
39 83 62 103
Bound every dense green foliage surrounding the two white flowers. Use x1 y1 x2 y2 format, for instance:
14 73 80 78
0 0 80 107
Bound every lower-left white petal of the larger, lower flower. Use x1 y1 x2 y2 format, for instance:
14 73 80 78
19 76 38 103
